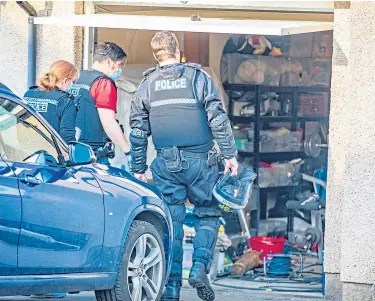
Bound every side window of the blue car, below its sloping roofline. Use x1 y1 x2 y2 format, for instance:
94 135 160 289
0 97 58 166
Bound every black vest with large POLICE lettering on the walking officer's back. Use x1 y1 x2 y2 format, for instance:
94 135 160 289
145 64 213 151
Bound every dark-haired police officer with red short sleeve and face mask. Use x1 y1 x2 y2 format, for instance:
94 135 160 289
71 42 130 164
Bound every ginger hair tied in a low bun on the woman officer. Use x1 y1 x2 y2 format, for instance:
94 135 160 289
39 60 78 91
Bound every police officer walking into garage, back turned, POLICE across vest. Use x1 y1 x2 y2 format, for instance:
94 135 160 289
130 31 238 301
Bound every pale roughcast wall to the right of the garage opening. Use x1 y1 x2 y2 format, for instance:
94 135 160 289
324 1 375 301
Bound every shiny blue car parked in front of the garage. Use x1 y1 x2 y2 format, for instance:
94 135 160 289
0 88 173 301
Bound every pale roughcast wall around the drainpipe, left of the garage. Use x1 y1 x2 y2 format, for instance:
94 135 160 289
0 1 83 95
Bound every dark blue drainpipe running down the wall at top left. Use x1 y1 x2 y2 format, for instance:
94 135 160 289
16 1 37 87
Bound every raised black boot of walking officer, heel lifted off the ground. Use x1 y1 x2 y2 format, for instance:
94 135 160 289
189 262 215 301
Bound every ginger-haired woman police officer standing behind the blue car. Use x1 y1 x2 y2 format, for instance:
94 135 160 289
24 60 78 143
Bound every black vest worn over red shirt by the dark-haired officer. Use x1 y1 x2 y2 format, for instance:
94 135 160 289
70 70 116 150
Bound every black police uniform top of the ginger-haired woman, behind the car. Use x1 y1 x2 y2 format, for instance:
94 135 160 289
24 87 77 143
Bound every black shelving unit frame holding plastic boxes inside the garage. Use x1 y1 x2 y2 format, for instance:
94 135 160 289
224 84 330 234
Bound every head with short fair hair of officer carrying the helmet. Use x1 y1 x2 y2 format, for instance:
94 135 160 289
151 31 180 62
